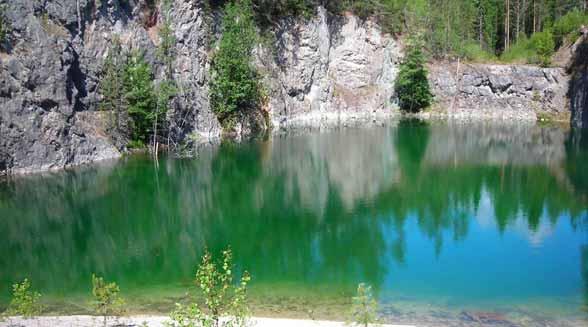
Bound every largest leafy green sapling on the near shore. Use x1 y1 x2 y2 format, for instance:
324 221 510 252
171 249 251 327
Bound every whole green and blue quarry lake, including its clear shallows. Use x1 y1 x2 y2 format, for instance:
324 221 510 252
0 121 588 325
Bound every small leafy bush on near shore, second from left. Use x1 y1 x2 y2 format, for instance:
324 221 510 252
92 275 125 326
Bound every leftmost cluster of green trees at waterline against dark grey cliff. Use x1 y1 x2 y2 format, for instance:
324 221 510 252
99 0 177 151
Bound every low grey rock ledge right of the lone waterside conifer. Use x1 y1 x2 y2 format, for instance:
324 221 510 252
429 63 569 121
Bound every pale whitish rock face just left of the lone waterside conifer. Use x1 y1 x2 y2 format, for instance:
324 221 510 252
257 8 400 127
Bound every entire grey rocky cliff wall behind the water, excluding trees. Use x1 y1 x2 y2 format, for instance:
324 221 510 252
0 0 580 173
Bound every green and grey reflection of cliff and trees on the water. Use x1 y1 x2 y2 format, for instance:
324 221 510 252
0 121 588 308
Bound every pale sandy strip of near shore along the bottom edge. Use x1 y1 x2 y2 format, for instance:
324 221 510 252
0 315 416 327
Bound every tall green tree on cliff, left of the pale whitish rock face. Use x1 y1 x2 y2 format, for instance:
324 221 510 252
210 0 261 128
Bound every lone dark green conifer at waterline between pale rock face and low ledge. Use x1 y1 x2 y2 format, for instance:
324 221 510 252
395 37 433 112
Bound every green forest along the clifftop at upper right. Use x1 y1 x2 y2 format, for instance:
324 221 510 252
208 0 587 60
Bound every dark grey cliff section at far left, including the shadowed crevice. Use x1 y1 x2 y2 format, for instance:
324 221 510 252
0 0 120 174
